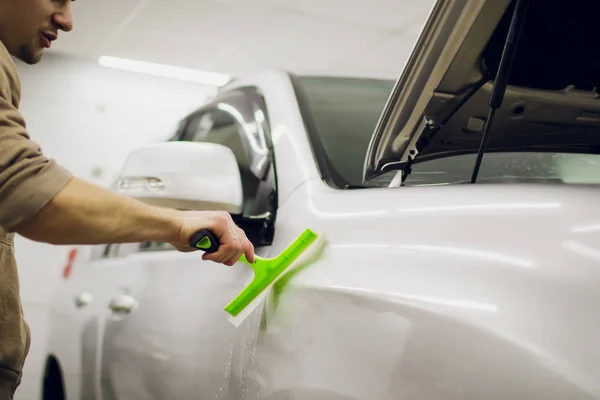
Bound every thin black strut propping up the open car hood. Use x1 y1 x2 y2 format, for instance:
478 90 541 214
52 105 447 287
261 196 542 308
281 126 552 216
471 0 529 183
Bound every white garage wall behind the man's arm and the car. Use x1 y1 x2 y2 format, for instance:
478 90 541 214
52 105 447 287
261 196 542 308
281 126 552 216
15 55 214 400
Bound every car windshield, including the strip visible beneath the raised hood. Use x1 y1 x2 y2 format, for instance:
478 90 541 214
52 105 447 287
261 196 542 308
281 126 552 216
298 77 600 188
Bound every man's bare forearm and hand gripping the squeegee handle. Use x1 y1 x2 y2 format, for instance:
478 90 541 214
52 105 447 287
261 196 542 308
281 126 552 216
14 178 254 265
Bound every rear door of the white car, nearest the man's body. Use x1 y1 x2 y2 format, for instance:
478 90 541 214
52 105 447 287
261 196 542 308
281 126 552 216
49 244 130 400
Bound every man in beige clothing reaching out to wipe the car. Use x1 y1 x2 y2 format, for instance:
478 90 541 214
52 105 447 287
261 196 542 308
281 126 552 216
0 0 254 400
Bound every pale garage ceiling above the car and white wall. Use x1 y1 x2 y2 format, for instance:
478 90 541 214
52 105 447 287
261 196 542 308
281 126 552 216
52 0 433 78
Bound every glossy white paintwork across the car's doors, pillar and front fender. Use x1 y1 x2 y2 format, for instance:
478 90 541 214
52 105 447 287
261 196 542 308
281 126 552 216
44 71 600 400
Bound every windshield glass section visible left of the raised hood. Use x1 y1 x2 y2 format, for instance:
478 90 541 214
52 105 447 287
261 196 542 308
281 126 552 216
297 77 395 188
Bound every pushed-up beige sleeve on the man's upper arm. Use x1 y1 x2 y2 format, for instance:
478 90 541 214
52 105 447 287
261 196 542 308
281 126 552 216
0 49 72 232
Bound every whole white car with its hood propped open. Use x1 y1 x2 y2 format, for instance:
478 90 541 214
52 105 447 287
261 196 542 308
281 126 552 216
44 0 600 400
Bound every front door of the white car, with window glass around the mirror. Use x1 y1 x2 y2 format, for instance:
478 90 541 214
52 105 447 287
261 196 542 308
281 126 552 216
100 89 276 400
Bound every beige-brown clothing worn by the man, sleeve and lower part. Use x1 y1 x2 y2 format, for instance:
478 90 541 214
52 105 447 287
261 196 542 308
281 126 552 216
0 42 72 399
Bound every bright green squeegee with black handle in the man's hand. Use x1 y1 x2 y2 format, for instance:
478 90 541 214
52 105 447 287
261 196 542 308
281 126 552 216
190 229 319 326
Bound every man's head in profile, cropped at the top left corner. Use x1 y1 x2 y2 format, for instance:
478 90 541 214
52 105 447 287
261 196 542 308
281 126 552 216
0 0 74 64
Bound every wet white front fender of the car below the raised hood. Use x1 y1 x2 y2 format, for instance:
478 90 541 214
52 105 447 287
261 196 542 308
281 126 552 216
230 180 600 399
